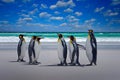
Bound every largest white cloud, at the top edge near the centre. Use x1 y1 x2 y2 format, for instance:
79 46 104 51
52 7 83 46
50 0 75 9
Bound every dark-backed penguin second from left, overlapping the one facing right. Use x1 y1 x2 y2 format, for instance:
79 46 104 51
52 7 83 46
28 36 36 64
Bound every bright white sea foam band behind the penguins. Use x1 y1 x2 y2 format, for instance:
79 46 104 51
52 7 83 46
0 36 120 42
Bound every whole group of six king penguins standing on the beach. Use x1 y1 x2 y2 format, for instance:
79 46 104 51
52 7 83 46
17 30 97 66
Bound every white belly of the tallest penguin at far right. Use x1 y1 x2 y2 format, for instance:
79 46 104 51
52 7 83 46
86 38 93 62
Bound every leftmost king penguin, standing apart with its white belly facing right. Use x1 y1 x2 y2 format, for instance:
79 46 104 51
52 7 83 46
17 34 27 62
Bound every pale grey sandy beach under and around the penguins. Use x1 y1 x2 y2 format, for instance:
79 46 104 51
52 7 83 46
0 43 120 80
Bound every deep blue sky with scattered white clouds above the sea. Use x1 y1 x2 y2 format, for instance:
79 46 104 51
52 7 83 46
0 0 120 32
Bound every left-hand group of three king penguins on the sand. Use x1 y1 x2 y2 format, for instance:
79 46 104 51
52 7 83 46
17 34 42 65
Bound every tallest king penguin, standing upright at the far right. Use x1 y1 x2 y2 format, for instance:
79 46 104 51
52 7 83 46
86 30 97 65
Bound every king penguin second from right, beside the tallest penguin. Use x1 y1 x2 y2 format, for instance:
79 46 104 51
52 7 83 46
69 36 81 66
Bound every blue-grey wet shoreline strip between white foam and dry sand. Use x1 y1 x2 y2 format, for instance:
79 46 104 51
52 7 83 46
0 42 120 50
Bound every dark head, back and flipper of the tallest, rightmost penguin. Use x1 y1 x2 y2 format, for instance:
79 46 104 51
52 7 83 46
89 30 97 65
